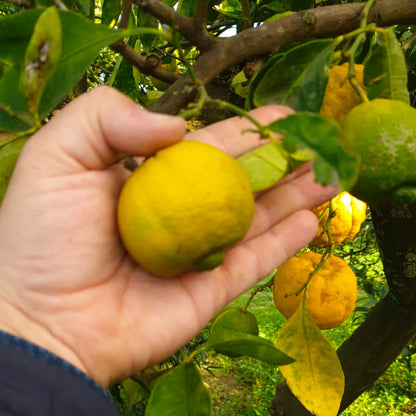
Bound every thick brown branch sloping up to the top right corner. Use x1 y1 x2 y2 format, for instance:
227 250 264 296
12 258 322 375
152 0 416 114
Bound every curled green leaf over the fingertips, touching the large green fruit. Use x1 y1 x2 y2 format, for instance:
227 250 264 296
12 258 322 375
269 112 359 190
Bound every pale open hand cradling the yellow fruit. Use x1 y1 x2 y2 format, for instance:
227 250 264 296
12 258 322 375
0 87 336 388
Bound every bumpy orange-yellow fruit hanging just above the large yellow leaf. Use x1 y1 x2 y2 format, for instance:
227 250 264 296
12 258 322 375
273 251 357 329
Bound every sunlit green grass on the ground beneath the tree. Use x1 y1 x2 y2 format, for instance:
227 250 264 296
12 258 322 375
203 274 416 416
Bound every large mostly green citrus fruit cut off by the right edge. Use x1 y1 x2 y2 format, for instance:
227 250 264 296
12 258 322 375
339 98 416 204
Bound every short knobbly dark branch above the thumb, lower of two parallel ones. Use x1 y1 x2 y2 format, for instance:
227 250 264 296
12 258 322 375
111 40 177 84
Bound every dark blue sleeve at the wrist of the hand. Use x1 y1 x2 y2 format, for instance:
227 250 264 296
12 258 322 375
0 331 120 416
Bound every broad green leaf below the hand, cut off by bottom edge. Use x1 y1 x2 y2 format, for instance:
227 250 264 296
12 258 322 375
145 362 213 416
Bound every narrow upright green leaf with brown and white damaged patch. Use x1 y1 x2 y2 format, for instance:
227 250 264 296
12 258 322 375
20 6 62 115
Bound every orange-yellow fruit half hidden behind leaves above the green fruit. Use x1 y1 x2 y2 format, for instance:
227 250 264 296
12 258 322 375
320 62 365 123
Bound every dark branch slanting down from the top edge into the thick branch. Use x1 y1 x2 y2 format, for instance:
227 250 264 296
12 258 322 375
134 0 215 51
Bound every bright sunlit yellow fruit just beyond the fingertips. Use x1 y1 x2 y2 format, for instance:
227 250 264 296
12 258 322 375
309 192 367 247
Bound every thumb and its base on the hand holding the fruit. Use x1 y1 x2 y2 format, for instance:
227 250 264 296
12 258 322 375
16 87 185 179
